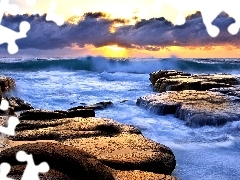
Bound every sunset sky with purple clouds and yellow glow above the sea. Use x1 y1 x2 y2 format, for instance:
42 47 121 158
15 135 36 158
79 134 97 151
0 0 240 58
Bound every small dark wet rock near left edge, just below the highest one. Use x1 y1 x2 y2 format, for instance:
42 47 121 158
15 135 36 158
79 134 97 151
6 97 34 112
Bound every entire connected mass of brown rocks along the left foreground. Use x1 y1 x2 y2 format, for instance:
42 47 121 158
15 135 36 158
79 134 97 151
0 77 177 180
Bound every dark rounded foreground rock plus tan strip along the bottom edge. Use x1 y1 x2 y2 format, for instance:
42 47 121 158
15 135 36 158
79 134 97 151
0 142 177 180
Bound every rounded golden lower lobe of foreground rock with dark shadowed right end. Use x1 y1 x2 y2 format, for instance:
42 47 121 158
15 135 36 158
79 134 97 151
63 133 176 175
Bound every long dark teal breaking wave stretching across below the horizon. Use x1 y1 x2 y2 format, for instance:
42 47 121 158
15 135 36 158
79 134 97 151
0 56 240 74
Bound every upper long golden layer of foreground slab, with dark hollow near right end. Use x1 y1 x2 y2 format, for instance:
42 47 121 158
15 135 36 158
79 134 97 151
11 117 141 141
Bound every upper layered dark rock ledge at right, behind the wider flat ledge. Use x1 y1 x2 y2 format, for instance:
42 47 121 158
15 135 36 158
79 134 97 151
150 71 239 92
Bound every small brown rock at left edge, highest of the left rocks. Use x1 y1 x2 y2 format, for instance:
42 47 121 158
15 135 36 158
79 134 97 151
0 76 16 99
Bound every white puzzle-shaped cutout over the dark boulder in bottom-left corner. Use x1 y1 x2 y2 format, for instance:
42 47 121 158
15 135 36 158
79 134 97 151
0 151 50 180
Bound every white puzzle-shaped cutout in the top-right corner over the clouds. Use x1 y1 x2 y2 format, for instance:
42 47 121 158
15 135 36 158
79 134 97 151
156 0 240 37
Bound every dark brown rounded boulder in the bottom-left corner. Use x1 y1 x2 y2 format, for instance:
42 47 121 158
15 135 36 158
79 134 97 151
0 143 114 180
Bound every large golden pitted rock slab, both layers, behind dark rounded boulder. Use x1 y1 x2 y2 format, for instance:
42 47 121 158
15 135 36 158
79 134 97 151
11 117 176 177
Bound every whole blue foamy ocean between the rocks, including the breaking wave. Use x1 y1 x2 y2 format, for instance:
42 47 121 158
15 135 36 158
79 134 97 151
0 56 240 180
